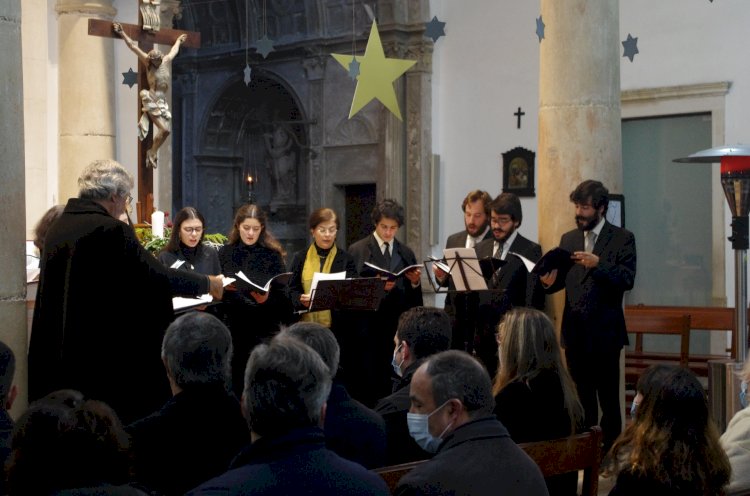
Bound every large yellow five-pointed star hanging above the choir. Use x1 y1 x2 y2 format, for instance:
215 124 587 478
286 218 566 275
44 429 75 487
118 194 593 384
331 21 417 121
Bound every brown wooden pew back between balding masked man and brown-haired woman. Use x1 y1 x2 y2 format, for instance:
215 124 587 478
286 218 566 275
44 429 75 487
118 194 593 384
519 425 602 496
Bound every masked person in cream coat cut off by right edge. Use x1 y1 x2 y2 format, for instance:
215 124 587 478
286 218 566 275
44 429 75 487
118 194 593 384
720 361 750 495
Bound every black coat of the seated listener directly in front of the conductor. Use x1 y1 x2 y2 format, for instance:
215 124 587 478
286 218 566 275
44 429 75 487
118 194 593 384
127 384 250 495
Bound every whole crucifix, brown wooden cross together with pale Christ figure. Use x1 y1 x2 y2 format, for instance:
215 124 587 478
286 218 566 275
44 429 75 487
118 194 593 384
89 9 201 224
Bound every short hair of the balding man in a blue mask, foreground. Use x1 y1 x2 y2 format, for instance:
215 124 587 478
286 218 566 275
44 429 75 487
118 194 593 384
423 350 495 418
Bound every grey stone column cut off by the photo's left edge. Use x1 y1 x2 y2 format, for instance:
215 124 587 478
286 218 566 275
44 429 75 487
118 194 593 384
0 0 28 415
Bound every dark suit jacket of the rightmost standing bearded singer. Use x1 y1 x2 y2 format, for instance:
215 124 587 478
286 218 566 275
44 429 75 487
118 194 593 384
547 222 636 352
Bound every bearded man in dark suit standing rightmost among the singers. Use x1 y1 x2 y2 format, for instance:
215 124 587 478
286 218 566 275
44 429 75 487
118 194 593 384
541 180 636 453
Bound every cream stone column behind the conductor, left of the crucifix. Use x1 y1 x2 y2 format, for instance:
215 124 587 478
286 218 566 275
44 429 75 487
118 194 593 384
56 0 117 203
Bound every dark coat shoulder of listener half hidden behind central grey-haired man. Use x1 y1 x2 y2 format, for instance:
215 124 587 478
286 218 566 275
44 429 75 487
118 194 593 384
323 380 386 469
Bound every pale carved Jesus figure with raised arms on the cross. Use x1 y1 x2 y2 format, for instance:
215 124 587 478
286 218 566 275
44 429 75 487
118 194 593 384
112 22 187 168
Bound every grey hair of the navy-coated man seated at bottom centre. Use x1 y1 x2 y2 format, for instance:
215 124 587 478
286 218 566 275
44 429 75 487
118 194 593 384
242 336 331 436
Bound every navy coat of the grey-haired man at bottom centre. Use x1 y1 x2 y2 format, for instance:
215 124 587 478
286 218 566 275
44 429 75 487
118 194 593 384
188 428 389 496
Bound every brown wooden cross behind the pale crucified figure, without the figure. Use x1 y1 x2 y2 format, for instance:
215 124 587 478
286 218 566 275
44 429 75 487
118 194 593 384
89 14 201 224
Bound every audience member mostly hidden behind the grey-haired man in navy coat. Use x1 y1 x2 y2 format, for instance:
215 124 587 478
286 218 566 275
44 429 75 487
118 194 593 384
280 322 386 468
